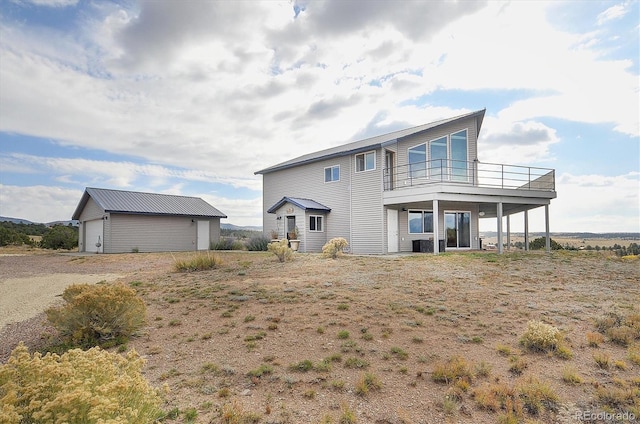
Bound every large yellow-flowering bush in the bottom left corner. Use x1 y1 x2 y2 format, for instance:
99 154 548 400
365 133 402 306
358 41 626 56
0 344 162 424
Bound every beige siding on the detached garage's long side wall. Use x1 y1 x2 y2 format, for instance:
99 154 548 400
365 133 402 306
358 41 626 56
105 214 198 253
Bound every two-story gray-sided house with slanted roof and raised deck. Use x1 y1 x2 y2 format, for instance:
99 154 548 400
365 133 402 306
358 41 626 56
256 110 556 254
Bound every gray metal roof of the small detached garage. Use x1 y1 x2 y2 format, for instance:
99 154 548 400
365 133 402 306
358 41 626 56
72 187 227 219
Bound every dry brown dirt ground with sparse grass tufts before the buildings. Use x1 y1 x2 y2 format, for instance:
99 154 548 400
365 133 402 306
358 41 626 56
0 247 640 423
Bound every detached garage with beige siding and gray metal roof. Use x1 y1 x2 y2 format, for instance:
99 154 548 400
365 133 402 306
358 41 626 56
72 187 227 253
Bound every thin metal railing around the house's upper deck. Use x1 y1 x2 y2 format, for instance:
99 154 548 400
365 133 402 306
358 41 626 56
384 159 555 191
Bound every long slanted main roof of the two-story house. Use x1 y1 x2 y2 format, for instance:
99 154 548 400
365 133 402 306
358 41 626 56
254 109 486 174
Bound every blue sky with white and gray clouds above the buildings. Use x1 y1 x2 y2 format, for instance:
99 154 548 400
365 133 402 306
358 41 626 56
0 0 640 232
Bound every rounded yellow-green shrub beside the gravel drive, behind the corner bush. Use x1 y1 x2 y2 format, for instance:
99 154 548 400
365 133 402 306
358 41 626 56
46 284 146 347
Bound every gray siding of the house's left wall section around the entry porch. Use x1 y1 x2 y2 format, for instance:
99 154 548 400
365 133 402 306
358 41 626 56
263 156 353 252
